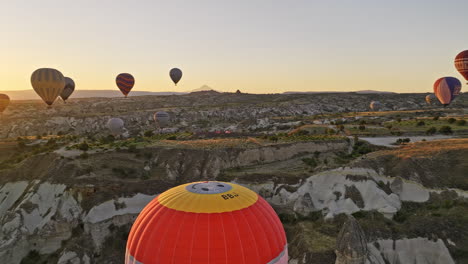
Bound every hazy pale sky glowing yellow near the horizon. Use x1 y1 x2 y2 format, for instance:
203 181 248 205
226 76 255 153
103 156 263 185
0 0 468 93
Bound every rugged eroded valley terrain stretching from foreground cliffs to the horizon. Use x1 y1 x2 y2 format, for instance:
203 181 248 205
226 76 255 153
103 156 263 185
0 92 468 264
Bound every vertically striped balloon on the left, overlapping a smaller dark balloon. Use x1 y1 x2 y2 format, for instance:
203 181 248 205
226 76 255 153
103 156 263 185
31 68 65 107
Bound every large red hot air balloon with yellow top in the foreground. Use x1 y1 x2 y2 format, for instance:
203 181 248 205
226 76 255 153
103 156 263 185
125 181 288 264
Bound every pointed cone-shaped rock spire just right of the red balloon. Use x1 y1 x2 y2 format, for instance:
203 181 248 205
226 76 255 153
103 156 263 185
335 216 368 264
